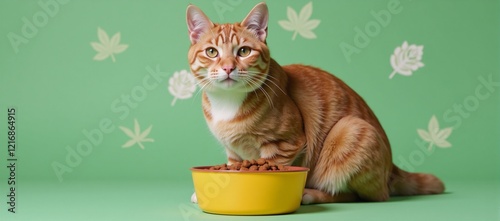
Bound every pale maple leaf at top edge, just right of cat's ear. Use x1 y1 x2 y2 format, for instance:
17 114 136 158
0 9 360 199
278 2 321 40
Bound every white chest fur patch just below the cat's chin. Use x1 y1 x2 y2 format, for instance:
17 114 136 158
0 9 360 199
207 92 247 124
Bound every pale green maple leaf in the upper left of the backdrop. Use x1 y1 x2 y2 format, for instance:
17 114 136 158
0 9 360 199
90 28 128 62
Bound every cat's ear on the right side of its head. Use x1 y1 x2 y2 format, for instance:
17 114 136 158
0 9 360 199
241 2 269 42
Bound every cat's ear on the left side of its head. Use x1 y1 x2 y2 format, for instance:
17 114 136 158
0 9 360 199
186 5 214 44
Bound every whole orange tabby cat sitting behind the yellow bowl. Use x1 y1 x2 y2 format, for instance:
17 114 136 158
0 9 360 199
187 3 444 204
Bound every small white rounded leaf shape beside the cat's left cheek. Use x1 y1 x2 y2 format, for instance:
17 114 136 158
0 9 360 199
168 70 196 106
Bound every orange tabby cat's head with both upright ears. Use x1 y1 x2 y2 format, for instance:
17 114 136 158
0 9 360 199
187 3 271 92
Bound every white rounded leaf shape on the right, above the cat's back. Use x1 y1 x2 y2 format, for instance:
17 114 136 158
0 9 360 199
389 41 424 79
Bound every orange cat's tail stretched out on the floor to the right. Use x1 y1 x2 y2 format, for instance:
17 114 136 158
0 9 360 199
389 165 444 196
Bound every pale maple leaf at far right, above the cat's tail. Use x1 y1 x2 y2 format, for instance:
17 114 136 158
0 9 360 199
417 115 452 150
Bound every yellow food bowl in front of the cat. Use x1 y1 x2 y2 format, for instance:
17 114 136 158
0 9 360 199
191 166 309 215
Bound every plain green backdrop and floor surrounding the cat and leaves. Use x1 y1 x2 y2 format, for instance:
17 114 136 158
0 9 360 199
0 0 500 220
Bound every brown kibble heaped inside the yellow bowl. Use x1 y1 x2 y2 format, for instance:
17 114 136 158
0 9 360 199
208 158 288 171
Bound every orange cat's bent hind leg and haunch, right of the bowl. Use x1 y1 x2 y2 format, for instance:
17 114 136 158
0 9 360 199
303 116 392 203
